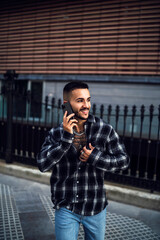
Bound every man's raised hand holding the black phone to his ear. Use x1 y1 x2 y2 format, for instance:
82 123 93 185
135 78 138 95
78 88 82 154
63 111 78 134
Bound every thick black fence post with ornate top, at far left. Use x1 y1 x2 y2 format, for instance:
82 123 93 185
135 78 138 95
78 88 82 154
4 70 18 163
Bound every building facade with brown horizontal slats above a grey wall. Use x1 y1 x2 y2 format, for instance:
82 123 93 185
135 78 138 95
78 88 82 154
0 0 160 109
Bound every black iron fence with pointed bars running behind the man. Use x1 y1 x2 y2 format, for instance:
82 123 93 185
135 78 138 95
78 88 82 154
0 71 160 191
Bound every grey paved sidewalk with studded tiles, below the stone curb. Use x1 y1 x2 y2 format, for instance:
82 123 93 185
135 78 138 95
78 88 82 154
0 174 160 240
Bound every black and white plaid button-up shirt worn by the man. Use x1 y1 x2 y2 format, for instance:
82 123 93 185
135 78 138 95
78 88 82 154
37 115 129 216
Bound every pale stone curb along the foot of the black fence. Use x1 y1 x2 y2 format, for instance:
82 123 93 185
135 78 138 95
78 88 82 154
0 160 160 211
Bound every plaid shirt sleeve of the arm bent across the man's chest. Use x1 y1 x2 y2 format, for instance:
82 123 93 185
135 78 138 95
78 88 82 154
87 128 130 172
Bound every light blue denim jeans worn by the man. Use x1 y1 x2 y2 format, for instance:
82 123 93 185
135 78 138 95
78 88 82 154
55 207 106 240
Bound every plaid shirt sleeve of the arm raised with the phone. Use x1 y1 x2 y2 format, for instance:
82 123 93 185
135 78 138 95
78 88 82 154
37 129 73 172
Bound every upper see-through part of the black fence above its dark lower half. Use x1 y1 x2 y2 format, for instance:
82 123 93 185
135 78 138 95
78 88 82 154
0 95 160 140
